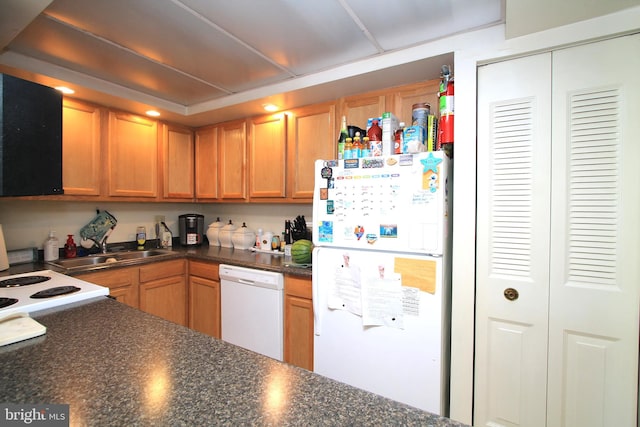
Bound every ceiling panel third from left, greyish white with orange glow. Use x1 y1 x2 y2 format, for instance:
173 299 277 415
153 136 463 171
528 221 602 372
182 0 378 75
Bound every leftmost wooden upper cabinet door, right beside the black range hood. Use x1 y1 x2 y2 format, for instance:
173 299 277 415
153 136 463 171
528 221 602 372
62 98 102 196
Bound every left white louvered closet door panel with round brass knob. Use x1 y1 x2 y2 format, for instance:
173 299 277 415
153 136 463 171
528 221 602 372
474 53 551 427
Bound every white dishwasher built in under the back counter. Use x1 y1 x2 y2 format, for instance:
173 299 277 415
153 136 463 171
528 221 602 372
219 264 284 360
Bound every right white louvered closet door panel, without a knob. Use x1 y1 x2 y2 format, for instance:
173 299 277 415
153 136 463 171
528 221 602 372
547 35 640 427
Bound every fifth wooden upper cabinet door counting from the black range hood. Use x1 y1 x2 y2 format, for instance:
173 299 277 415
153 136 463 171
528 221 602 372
218 120 247 200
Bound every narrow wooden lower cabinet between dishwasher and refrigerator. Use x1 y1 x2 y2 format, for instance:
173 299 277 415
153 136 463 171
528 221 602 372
284 275 313 371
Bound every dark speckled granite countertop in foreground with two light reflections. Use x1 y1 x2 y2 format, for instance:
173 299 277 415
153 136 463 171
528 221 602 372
0 298 470 426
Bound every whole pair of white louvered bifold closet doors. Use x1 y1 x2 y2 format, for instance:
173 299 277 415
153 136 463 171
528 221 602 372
474 35 640 427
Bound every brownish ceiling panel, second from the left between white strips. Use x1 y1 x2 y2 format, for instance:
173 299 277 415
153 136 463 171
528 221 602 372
40 0 290 93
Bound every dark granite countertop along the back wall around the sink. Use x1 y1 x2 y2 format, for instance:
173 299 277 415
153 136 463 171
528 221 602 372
0 245 311 278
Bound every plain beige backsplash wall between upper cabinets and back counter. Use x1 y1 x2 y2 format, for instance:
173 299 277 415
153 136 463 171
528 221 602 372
0 200 312 250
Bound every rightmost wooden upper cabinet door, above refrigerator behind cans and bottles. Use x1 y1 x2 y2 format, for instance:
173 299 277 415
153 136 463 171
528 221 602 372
387 79 440 126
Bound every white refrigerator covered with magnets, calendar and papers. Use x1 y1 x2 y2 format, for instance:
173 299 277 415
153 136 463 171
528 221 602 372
312 152 452 416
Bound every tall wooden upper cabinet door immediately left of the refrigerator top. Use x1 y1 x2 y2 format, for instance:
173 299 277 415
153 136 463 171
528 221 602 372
287 103 338 201
